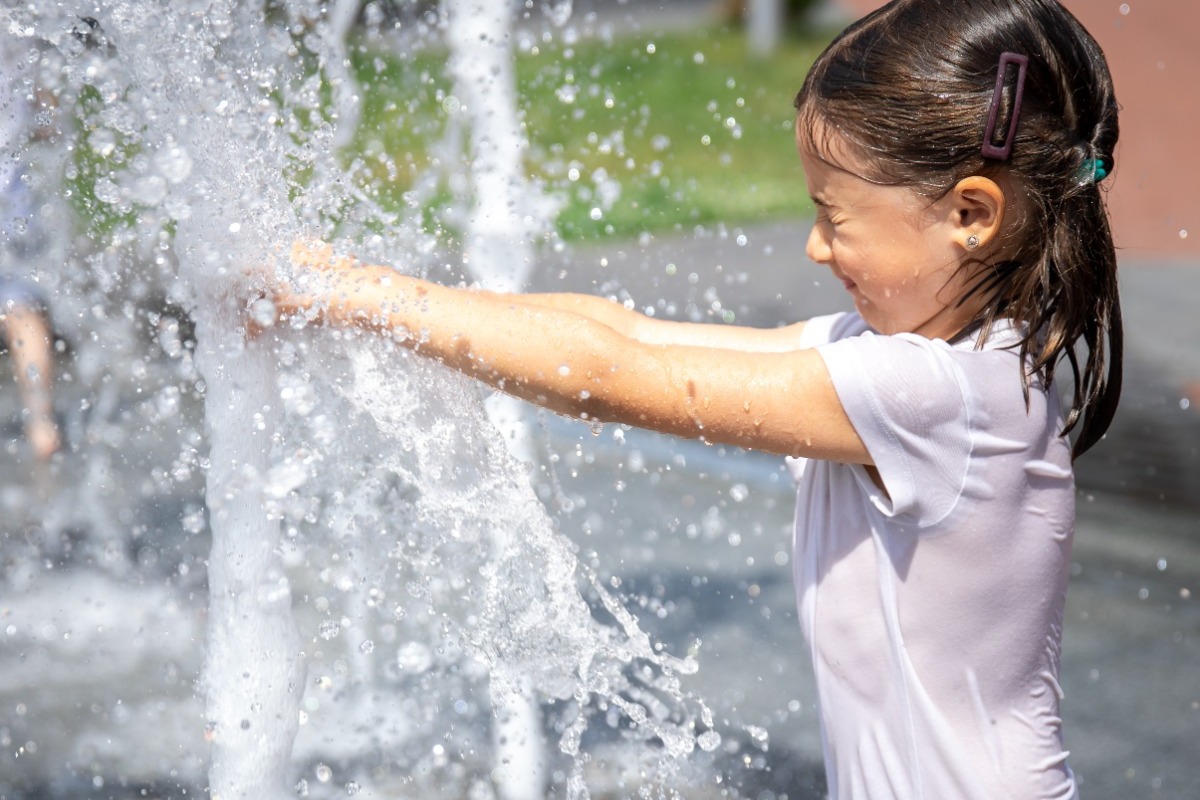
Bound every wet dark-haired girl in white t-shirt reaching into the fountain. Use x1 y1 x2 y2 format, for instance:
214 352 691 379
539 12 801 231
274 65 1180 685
276 0 1121 800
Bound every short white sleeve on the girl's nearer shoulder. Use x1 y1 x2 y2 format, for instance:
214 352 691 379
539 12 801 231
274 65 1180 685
817 331 971 527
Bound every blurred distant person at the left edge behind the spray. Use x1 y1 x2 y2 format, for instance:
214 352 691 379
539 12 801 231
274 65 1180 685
0 35 61 461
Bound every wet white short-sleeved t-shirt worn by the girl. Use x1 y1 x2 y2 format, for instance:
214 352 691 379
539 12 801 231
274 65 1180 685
790 313 1076 800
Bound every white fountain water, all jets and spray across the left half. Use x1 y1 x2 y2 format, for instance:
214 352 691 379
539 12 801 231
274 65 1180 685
5 0 720 800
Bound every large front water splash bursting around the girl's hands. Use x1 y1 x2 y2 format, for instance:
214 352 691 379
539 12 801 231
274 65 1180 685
13 0 712 799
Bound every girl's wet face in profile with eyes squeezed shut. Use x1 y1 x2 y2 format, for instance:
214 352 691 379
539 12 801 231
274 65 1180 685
797 123 973 338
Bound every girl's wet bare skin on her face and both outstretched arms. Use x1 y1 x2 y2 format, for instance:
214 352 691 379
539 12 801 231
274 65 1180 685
272 128 1003 472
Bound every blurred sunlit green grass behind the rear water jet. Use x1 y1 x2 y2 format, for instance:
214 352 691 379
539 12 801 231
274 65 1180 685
346 28 829 240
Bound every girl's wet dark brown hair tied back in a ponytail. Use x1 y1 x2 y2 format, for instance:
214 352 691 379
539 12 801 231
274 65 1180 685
796 0 1122 457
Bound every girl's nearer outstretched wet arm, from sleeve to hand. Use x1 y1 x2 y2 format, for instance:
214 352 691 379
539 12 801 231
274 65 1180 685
276 247 869 463
